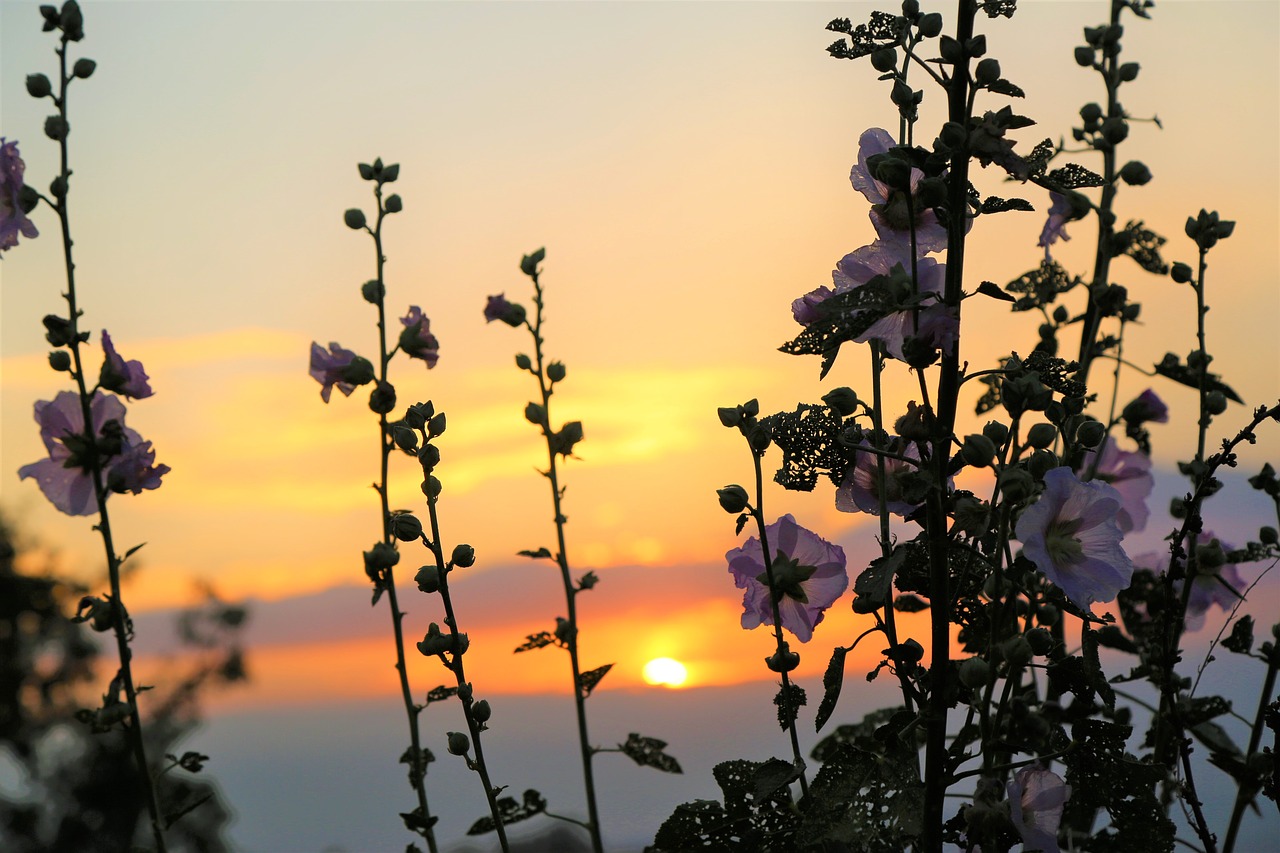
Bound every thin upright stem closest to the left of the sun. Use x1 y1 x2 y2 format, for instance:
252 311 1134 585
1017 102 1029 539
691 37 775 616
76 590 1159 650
526 272 604 853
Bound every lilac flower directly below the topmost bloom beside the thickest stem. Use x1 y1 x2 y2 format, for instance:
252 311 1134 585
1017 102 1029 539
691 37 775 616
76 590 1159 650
834 241 960 361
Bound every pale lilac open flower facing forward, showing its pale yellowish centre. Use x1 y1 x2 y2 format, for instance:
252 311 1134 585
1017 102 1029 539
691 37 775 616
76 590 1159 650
1014 466 1134 610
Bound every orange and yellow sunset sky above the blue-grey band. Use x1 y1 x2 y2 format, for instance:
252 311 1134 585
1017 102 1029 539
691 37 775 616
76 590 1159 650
0 0 1280 845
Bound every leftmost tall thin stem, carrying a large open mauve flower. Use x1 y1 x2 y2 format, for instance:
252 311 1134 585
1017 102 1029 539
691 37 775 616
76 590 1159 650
56 38 166 853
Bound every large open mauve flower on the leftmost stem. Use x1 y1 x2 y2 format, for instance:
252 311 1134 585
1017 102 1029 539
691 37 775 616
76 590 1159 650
18 391 170 515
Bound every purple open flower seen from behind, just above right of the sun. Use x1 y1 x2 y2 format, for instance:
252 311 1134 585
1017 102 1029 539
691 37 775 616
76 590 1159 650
724 515 849 643
